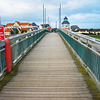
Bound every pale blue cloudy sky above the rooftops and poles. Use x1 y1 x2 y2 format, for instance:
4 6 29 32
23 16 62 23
0 0 100 28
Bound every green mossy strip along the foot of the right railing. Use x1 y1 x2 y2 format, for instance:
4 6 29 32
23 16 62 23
59 34 100 100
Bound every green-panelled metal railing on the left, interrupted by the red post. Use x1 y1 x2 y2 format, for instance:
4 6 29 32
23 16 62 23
0 29 49 78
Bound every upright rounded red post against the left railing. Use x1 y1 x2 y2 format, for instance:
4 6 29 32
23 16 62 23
5 39 12 73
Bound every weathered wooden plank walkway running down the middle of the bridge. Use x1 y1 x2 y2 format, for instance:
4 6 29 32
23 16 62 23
0 33 92 100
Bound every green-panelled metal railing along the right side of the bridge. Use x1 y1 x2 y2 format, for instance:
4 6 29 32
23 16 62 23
57 29 100 86
